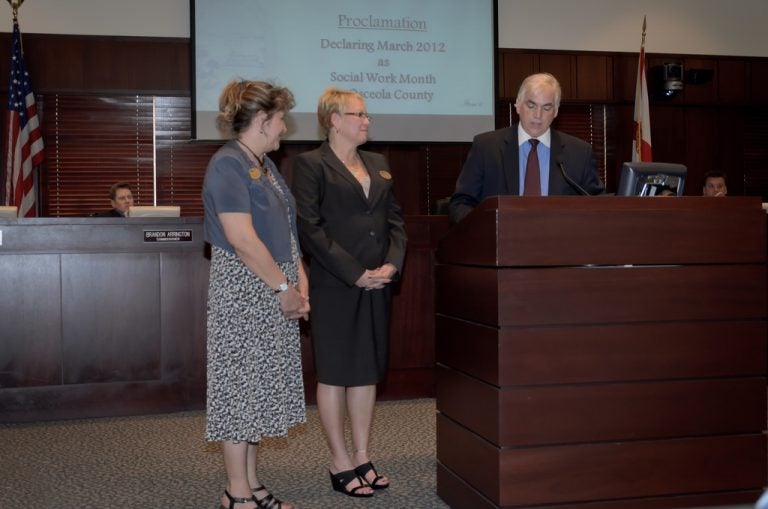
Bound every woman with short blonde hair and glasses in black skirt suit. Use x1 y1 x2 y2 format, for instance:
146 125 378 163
293 88 406 497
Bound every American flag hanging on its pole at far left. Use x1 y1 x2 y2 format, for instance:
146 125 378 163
4 17 44 217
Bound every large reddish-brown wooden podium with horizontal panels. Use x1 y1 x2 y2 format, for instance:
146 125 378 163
436 196 768 509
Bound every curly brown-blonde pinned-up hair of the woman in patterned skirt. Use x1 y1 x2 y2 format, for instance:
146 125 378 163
216 80 296 136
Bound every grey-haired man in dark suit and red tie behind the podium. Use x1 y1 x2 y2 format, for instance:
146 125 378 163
448 73 604 223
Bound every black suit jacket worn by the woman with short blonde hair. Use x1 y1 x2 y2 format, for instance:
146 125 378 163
292 142 406 286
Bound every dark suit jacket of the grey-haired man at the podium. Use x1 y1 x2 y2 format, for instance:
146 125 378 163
449 124 605 223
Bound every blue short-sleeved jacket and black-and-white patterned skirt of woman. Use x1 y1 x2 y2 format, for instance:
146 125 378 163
203 141 306 443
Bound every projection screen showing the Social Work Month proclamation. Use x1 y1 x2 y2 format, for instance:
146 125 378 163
190 0 497 142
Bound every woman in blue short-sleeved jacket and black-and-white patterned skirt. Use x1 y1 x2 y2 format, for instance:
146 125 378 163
203 81 309 509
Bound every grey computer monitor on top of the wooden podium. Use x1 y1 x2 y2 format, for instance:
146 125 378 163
616 162 688 196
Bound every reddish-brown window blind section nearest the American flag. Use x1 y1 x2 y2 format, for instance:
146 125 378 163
39 94 154 217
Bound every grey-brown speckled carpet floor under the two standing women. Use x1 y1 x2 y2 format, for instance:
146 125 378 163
0 399 448 509
